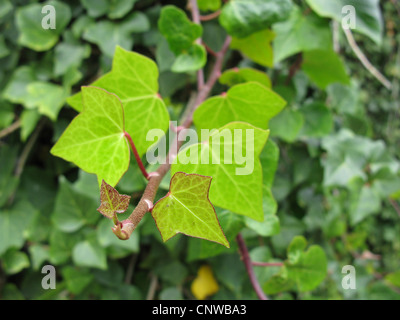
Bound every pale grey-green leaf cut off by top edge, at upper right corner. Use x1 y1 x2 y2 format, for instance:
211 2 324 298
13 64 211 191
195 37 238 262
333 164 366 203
306 0 383 45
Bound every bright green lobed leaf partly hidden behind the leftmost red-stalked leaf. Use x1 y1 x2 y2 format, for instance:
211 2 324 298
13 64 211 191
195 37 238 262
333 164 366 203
67 47 169 158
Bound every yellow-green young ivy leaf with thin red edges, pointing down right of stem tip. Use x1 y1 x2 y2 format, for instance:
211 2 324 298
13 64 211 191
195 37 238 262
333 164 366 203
151 172 229 248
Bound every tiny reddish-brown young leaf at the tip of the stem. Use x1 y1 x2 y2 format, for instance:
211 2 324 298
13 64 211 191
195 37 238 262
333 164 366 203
97 180 131 219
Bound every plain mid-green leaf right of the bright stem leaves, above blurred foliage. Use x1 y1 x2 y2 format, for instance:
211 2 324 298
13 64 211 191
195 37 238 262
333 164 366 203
302 50 350 90
